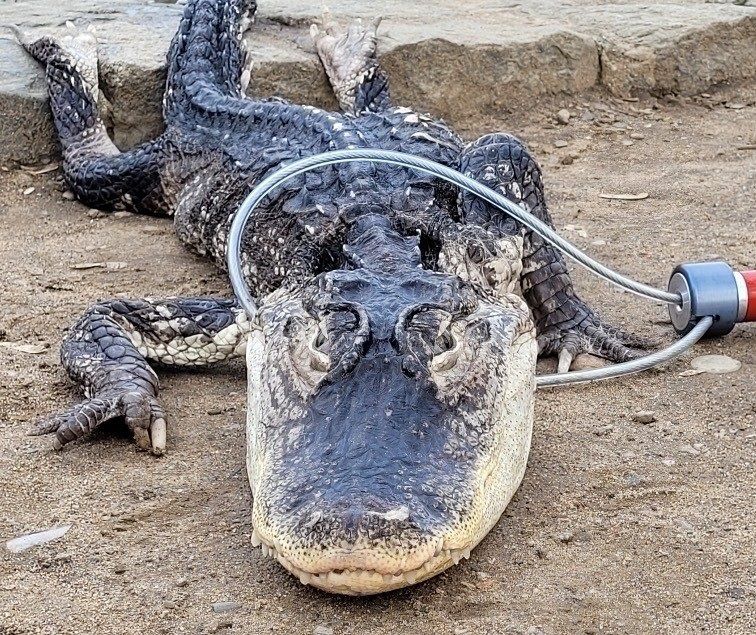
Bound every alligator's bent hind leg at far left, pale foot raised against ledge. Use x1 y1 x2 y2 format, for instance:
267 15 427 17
16 23 167 213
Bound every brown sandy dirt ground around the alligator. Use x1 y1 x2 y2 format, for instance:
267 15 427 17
0 88 756 635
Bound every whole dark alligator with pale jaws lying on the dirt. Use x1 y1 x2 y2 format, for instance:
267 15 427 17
17 0 647 595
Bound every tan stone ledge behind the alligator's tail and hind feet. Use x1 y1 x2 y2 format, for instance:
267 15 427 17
0 0 756 163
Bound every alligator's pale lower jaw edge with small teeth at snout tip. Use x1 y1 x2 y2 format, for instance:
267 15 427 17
252 530 470 595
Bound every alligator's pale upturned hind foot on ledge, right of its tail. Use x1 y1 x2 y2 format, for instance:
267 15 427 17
310 11 381 112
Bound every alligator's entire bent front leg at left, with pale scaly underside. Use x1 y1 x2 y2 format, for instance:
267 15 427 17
30 298 251 454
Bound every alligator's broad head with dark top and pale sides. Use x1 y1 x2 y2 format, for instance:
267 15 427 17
247 215 536 595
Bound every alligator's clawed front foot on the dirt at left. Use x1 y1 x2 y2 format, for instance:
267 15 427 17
28 390 166 455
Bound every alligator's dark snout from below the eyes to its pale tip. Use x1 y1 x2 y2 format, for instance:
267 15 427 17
250 356 465 594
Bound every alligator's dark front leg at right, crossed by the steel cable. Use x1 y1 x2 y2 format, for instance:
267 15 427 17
452 134 651 372
